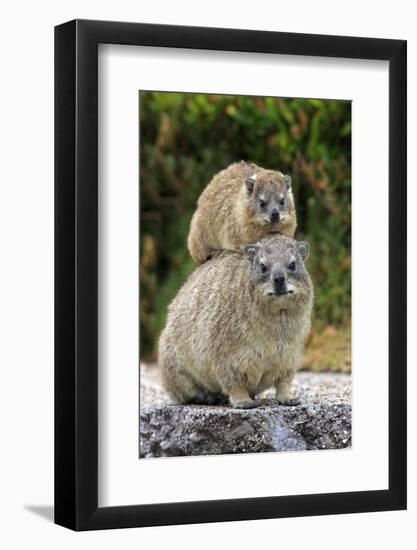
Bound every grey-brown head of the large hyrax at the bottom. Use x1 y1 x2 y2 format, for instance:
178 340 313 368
245 235 312 303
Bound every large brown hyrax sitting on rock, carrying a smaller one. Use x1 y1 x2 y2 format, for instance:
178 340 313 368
159 235 313 408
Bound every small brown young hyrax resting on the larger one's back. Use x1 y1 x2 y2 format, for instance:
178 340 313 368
188 161 297 263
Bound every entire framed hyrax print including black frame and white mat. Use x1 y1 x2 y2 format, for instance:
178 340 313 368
55 20 406 530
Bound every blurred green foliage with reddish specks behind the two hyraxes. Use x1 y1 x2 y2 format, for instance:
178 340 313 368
140 92 351 357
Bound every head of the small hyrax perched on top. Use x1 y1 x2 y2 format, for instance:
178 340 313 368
245 169 294 227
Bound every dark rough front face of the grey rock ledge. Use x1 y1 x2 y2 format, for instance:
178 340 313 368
140 403 351 457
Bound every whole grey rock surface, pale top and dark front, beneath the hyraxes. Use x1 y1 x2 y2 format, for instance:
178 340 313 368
139 366 351 458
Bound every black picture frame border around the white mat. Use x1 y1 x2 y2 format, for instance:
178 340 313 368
55 20 407 530
